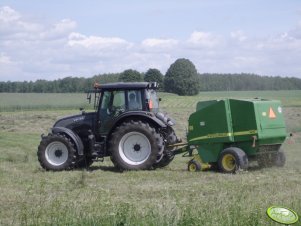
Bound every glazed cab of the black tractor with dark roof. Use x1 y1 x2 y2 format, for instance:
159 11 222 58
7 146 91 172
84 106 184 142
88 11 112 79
88 82 163 135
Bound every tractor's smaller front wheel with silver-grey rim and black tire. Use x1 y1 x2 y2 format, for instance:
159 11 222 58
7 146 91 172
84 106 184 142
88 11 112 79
37 134 77 171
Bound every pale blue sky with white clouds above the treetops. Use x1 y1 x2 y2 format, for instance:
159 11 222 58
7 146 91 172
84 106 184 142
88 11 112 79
0 0 301 81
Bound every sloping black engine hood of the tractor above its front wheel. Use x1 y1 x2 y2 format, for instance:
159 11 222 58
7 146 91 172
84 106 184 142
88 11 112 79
53 112 96 130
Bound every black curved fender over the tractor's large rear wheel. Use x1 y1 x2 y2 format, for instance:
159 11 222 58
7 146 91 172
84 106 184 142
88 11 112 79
110 111 167 132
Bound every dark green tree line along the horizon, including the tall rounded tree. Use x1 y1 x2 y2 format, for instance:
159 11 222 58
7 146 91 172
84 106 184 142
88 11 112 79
0 59 301 95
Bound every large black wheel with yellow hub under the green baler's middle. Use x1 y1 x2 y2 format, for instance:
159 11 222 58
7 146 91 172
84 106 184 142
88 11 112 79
218 147 249 173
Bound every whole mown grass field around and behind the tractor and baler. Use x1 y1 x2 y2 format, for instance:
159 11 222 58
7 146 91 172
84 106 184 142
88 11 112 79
0 91 301 226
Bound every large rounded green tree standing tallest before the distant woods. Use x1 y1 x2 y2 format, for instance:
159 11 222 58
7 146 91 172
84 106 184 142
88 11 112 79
164 58 199 96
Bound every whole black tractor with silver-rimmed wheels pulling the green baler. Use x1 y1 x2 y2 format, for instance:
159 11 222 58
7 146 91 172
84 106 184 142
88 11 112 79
38 82 177 171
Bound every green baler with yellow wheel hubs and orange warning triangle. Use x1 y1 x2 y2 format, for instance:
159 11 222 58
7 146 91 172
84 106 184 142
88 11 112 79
187 99 287 173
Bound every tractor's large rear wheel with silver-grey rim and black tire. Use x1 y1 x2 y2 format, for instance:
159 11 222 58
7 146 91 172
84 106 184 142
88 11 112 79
109 120 163 170
